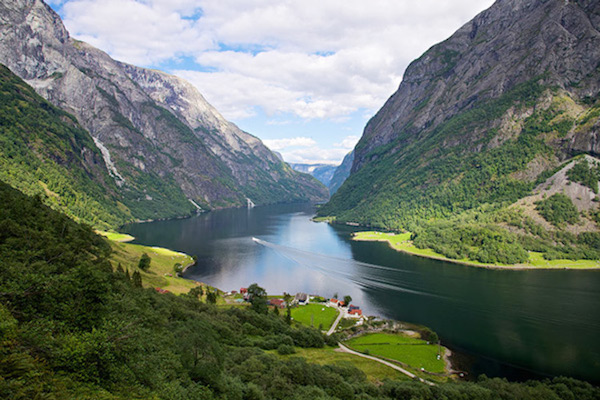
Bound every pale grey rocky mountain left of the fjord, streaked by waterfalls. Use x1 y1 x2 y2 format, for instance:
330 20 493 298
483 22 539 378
0 0 327 225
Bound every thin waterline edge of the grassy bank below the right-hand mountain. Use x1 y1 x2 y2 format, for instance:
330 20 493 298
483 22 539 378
352 231 600 271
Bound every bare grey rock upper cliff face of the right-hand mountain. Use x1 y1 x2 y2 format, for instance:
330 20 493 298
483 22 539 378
353 0 600 171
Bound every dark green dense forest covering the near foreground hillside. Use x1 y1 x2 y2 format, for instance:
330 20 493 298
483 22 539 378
0 183 600 400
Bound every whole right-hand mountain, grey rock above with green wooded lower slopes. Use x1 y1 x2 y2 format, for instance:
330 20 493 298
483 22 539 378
319 0 600 266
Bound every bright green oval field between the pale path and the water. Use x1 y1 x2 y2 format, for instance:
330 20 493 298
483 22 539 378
345 333 445 373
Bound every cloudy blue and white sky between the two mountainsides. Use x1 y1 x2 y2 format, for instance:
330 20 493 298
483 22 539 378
48 0 493 164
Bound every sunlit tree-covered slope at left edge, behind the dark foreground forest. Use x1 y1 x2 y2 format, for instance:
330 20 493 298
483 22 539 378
0 65 132 227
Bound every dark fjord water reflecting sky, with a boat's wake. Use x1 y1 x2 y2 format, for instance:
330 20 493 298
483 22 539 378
126 204 600 382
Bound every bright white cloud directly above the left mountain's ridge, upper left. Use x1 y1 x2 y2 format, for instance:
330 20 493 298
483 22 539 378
62 0 216 65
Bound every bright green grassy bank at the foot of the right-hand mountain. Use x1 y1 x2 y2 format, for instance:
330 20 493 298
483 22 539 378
352 231 600 270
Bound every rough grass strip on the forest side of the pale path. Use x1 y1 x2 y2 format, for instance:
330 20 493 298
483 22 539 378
280 347 410 383
